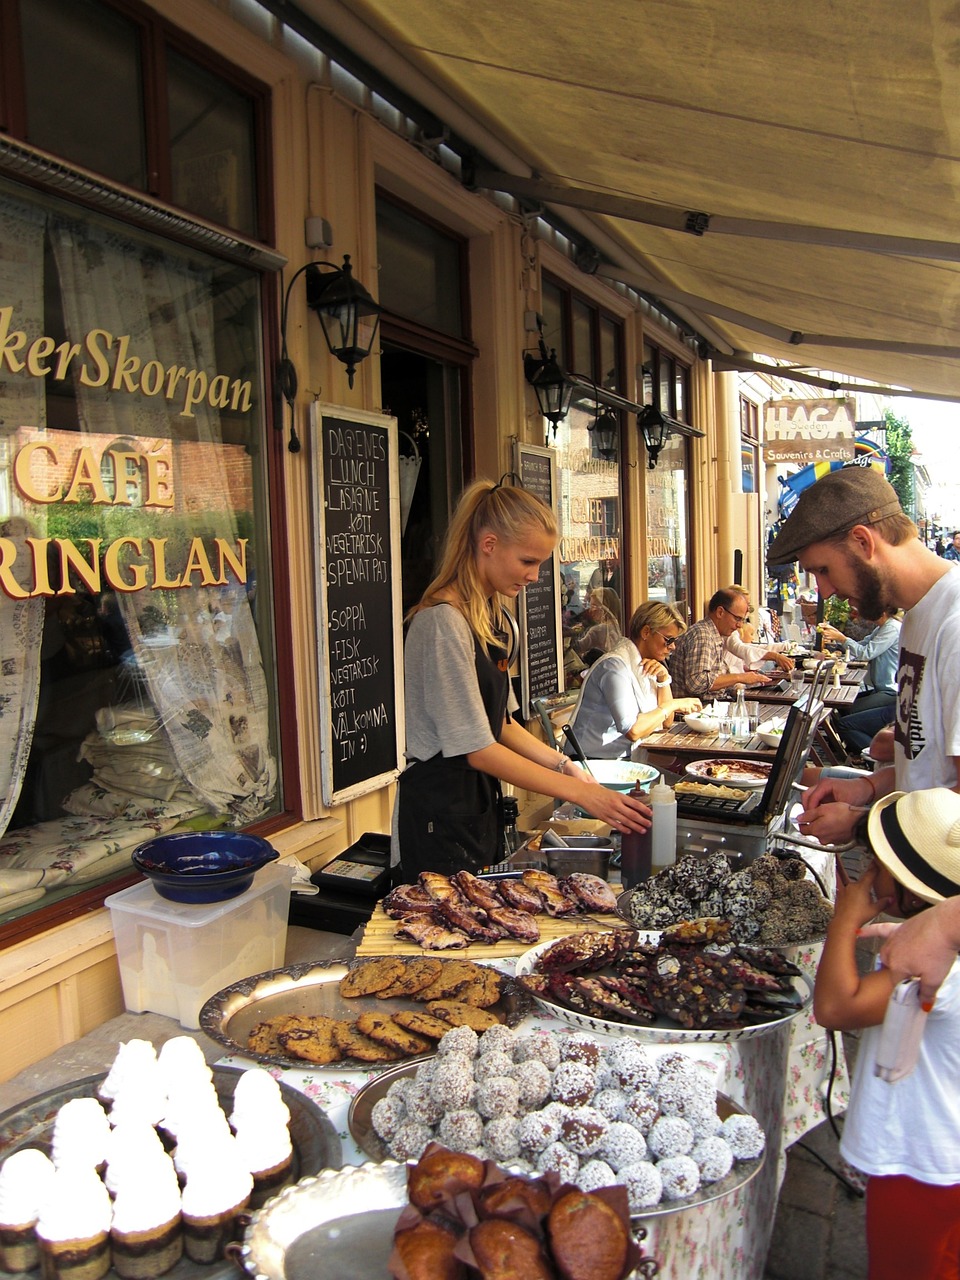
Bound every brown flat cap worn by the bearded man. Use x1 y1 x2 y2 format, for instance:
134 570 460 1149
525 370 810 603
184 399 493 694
767 467 904 566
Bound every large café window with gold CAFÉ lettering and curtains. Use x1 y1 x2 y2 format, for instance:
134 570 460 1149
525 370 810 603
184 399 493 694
0 182 282 923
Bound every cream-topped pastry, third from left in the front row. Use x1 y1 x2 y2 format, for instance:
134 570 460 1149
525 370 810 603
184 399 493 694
110 1151 183 1280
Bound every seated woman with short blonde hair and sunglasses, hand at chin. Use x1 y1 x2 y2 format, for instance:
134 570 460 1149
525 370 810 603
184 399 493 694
564 600 700 760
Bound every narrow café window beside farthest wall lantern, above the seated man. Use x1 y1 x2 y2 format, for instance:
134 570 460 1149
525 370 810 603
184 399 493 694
637 342 692 617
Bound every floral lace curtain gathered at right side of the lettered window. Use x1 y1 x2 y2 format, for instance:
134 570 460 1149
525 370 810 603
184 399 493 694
50 218 276 826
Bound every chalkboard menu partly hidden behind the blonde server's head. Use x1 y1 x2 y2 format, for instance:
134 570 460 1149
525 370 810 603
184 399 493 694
515 442 563 719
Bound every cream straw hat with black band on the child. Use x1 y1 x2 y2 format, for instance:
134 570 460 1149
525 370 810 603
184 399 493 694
867 787 960 902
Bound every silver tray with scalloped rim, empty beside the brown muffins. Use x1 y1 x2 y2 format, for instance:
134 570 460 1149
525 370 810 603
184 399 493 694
239 1160 407 1280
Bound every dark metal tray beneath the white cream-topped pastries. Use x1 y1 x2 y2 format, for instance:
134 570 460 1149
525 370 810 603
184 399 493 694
0 1066 343 1280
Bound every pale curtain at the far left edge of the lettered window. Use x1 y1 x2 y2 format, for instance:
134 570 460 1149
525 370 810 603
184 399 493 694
0 198 45 836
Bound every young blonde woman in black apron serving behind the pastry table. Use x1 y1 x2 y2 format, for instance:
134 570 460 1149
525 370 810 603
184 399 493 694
394 480 650 881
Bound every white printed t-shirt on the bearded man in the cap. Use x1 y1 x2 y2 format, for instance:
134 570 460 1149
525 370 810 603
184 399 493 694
893 568 960 791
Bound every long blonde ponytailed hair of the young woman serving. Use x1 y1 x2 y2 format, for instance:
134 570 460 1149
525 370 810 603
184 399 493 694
407 480 557 648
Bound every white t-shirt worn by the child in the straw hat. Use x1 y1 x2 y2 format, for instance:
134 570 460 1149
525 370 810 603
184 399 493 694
840 961 960 1187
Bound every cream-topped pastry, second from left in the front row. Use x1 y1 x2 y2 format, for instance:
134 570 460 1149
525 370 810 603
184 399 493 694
37 1164 113 1280
